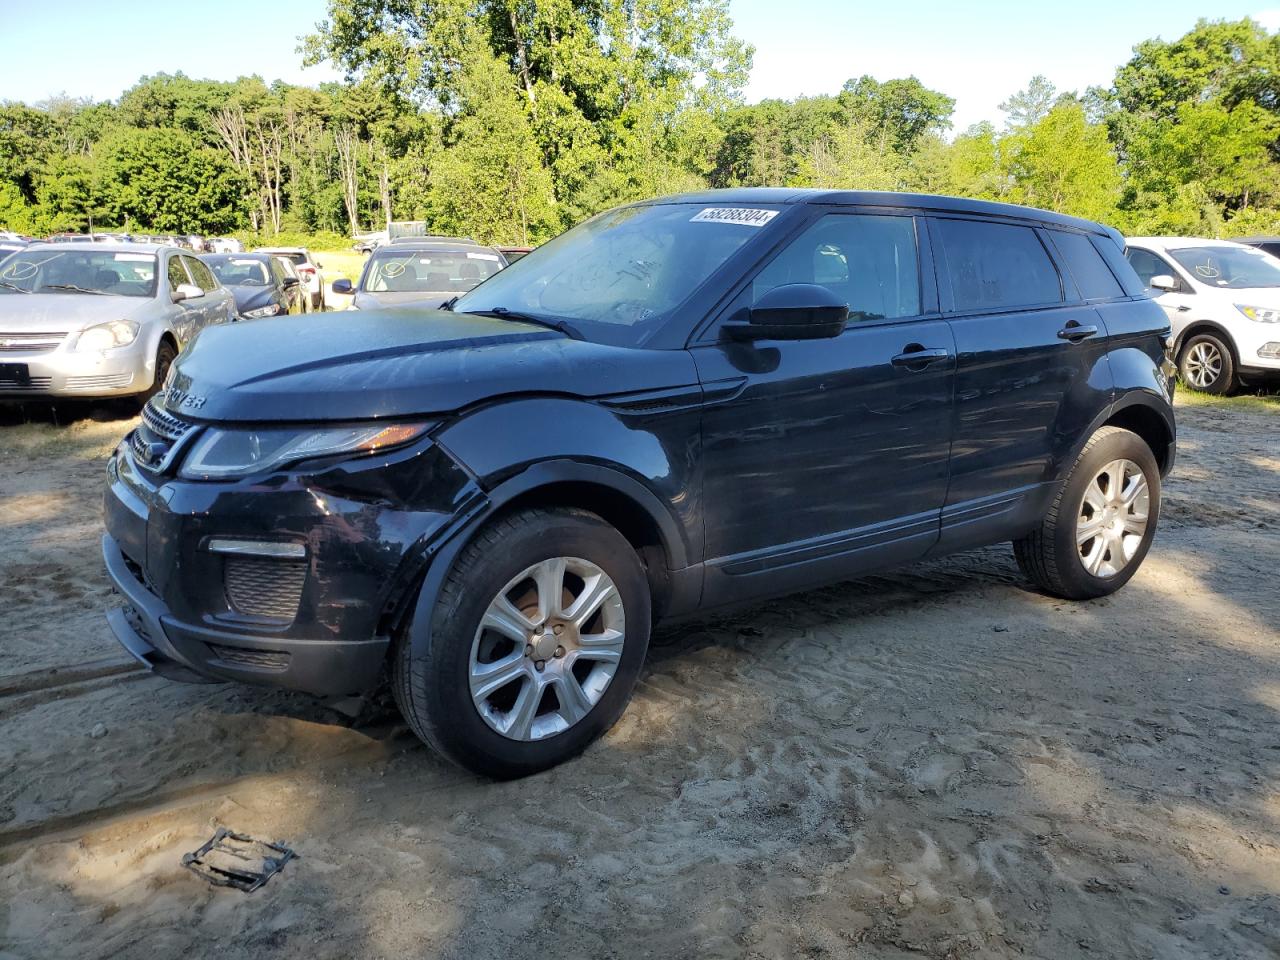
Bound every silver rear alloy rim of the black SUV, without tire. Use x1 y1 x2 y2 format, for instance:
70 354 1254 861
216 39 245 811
1075 460 1151 579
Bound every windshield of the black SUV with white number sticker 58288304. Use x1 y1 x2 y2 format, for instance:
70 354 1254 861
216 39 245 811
454 204 778 346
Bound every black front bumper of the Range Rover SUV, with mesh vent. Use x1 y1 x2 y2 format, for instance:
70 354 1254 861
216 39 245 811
102 432 474 696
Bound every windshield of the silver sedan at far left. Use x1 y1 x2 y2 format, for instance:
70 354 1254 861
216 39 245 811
0 248 156 297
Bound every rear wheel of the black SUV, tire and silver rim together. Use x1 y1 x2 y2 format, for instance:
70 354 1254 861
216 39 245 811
1014 426 1160 600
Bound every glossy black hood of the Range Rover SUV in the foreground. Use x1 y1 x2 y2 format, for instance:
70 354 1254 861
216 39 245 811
166 310 698 421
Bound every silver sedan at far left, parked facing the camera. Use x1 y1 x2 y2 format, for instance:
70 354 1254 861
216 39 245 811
0 241 234 399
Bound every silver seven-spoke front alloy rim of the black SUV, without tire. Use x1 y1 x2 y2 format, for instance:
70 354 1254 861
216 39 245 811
470 557 626 741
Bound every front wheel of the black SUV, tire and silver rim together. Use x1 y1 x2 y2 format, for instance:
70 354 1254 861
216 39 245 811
392 509 652 780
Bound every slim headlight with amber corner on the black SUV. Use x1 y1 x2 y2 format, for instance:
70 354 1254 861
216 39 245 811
178 424 431 480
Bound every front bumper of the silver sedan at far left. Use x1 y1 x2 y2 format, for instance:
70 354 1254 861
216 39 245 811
0 337 155 399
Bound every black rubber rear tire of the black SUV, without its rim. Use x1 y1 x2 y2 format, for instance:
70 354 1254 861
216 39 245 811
1014 426 1160 600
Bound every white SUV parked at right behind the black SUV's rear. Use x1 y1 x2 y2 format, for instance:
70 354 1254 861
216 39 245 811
1125 237 1280 393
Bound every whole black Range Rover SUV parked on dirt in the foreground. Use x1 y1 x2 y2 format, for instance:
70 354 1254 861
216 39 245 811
102 189 1174 777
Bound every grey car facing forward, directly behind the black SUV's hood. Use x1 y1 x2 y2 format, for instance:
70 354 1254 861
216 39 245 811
333 241 507 310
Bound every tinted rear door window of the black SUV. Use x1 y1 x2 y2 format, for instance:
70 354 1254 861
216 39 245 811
936 220 1062 310
